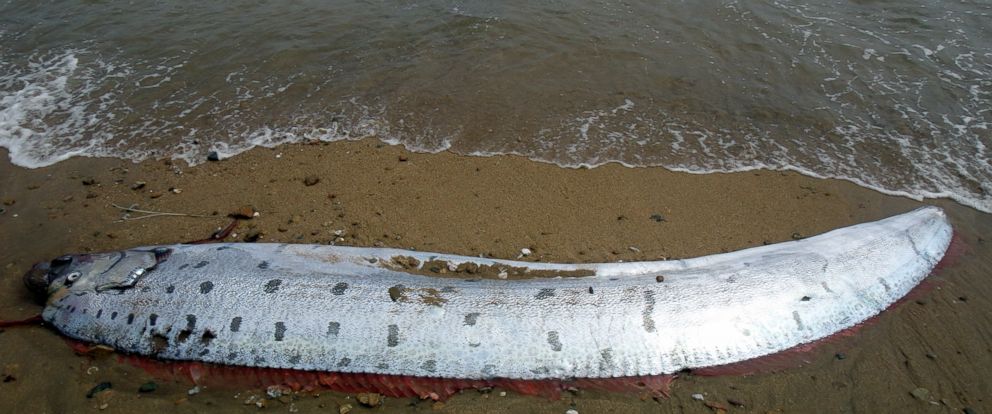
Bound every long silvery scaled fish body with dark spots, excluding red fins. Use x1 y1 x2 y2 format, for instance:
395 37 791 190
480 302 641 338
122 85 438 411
36 207 952 379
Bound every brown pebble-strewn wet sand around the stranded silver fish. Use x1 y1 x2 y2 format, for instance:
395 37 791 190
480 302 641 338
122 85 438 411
0 140 992 413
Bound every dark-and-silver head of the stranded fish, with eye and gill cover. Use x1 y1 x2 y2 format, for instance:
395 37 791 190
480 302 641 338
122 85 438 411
24 247 171 298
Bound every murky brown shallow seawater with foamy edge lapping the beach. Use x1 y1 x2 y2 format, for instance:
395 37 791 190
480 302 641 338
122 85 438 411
0 0 992 212
